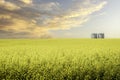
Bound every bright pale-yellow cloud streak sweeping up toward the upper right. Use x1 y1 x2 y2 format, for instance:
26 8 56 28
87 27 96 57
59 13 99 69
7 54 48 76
41 1 106 29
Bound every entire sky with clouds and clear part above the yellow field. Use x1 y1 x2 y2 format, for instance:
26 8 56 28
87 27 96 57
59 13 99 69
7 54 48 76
0 0 120 38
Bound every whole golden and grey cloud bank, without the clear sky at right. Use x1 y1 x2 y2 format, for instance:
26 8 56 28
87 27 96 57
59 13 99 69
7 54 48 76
0 0 107 38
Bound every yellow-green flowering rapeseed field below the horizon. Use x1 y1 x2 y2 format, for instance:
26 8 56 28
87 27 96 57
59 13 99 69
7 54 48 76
0 39 120 80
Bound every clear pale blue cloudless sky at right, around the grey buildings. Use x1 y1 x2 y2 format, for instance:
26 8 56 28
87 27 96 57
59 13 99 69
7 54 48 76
50 0 120 38
